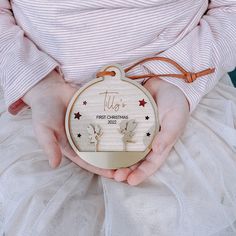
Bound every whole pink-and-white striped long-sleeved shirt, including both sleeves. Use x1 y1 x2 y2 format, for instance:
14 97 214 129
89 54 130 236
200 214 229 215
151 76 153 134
0 0 236 114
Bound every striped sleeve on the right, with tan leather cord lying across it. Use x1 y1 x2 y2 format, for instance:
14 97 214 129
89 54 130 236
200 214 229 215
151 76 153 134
136 0 236 112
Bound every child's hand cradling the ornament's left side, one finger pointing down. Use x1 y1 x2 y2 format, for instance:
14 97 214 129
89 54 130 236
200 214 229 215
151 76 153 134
23 71 114 178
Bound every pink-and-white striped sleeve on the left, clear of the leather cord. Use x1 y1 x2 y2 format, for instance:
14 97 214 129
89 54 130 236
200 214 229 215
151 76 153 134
0 0 58 113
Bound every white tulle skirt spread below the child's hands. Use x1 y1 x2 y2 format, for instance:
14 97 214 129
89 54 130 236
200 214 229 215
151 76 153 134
0 76 236 236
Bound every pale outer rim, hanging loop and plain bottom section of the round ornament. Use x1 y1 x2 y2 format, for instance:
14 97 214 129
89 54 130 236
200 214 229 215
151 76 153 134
65 64 159 169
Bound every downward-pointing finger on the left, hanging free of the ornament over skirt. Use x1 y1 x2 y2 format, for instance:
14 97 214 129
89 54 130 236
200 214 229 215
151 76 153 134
35 125 62 168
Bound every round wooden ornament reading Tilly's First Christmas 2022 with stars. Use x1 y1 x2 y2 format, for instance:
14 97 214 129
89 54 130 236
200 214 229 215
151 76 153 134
65 65 159 169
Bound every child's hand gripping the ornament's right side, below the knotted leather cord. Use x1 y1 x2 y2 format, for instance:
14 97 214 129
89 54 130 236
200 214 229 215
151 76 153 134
114 78 189 185
